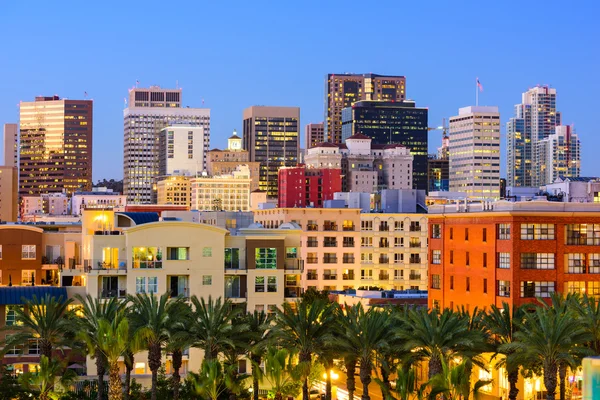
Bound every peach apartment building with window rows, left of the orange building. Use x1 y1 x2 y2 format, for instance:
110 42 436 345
255 208 427 290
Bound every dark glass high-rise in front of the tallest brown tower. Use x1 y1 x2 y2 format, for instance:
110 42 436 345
342 101 428 190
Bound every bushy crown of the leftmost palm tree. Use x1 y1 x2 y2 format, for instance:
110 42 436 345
3 294 75 359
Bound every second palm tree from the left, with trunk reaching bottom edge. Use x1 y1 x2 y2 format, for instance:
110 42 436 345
75 294 123 400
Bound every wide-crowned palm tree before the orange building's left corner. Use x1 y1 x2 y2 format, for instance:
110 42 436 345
398 308 481 379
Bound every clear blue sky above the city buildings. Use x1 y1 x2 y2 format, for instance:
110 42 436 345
0 0 600 180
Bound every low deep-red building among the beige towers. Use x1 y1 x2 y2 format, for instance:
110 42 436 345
278 165 342 208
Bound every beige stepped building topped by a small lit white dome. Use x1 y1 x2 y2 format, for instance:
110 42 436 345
206 130 260 192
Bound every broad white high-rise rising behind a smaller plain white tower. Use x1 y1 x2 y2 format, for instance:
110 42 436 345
123 86 210 204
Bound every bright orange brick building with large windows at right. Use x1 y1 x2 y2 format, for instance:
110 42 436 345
429 201 600 310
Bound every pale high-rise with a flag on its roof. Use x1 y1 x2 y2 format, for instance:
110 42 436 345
449 106 500 200
